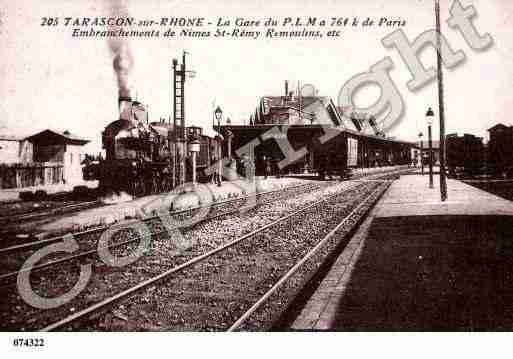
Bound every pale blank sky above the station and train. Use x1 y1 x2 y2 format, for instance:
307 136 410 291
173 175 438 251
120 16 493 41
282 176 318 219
0 0 513 153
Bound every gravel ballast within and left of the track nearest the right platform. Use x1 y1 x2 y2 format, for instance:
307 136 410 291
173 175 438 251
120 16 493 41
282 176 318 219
0 172 404 331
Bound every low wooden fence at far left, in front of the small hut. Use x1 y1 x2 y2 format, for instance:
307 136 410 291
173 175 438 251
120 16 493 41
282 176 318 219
0 163 64 188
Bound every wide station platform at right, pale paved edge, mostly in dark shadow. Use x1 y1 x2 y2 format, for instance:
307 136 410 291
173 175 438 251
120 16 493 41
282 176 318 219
290 175 513 331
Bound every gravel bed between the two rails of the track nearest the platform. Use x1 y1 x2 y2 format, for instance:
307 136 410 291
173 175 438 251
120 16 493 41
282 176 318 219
74 183 388 331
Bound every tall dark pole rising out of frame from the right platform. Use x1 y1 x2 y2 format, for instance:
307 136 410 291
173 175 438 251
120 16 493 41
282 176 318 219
435 0 447 202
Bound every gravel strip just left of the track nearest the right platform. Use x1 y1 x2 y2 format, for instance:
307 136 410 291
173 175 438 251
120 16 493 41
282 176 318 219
0 182 336 330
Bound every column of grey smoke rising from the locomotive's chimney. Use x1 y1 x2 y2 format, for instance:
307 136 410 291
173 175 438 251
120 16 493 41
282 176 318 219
108 0 133 98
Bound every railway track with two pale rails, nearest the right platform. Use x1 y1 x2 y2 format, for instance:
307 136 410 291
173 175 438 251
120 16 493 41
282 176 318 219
42 180 387 331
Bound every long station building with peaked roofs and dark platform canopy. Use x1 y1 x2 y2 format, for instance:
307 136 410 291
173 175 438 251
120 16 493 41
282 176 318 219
214 85 415 173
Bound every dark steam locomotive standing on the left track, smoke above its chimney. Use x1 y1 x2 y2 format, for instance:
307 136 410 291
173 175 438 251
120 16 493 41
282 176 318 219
84 97 218 197
